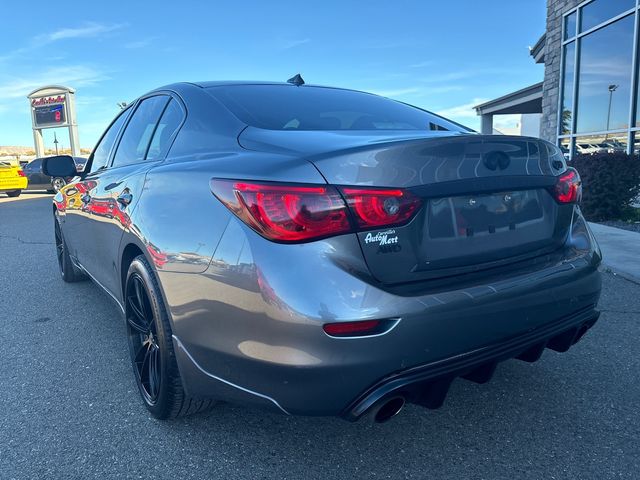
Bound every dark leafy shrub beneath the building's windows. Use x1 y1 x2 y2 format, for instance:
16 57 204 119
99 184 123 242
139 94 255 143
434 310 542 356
571 152 640 222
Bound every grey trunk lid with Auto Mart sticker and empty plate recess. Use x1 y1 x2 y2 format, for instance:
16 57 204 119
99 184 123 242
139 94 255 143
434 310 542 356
238 132 573 284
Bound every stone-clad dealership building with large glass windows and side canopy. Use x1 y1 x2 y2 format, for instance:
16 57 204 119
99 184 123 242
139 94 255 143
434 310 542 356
475 0 640 155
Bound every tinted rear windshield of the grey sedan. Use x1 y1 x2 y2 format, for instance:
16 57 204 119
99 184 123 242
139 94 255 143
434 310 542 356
207 85 469 131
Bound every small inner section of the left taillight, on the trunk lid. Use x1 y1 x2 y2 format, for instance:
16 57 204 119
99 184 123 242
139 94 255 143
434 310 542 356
342 187 420 229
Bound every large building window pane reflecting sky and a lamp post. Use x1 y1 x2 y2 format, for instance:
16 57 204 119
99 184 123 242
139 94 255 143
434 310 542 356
577 15 634 133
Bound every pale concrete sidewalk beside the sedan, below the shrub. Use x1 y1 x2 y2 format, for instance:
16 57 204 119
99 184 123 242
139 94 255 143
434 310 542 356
589 223 640 282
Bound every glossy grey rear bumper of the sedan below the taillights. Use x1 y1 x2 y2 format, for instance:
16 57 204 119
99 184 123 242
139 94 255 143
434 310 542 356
158 212 601 419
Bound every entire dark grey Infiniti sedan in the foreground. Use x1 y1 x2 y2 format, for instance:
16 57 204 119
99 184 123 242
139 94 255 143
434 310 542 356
43 77 601 422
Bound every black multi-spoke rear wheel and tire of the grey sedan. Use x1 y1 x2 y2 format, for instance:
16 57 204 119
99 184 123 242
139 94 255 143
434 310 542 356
124 255 215 420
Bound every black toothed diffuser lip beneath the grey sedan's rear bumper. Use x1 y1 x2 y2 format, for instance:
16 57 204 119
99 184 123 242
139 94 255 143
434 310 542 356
342 306 600 421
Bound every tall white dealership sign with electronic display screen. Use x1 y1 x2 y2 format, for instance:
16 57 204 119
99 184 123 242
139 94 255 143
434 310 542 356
27 85 80 157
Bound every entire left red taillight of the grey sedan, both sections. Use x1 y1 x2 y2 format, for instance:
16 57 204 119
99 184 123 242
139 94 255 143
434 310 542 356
211 179 420 242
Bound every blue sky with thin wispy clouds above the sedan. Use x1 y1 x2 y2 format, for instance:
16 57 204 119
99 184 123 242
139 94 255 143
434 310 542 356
0 0 546 148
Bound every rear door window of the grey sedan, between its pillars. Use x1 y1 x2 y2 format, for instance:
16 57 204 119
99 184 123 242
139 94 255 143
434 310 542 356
112 95 169 167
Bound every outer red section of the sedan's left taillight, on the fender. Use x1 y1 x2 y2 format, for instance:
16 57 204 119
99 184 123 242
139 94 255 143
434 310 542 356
211 179 351 242
